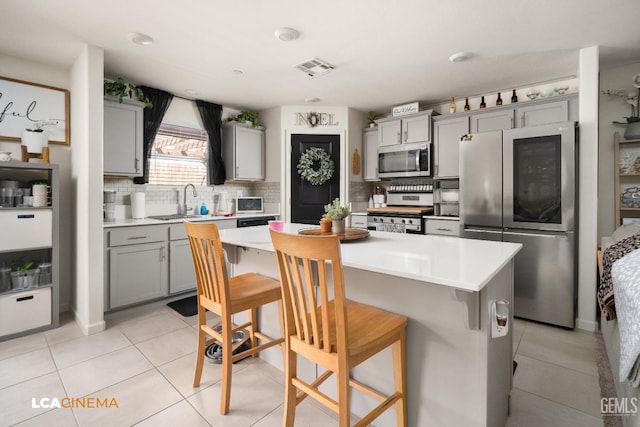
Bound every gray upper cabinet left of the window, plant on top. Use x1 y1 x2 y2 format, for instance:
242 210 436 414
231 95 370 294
103 97 144 176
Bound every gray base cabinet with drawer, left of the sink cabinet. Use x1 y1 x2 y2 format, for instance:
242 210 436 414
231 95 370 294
105 225 169 309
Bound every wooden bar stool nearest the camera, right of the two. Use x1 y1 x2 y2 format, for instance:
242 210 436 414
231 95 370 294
269 230 407 427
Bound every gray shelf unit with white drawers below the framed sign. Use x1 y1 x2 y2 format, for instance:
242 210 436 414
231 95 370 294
0 161 60 341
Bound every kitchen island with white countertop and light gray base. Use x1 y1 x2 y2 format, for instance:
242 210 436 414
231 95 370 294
220 224 521 427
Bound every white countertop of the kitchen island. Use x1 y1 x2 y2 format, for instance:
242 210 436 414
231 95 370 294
220 223 522 291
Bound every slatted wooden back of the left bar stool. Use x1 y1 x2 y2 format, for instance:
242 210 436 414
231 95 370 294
184 222 229 313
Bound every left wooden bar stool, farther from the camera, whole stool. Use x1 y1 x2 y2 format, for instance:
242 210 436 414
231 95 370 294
184 222 284 415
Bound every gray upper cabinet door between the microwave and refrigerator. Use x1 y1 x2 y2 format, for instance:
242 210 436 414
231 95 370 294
433 116 469 179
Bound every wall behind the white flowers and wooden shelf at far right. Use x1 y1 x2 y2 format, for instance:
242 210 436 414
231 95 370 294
598 62 640 239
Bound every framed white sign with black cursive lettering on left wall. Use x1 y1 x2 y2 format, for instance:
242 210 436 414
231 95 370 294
0 77 69 145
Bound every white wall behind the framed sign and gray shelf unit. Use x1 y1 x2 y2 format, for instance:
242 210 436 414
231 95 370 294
0 55 74 311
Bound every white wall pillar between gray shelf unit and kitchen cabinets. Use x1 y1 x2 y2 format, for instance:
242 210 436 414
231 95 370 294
71 46 105 334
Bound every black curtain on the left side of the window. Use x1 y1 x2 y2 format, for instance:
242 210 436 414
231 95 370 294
133 86 173 184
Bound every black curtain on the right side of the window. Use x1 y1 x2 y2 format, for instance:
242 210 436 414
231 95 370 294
196 99 226 185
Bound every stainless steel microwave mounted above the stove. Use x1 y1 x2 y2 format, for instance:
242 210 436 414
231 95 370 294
378 142 431 178
